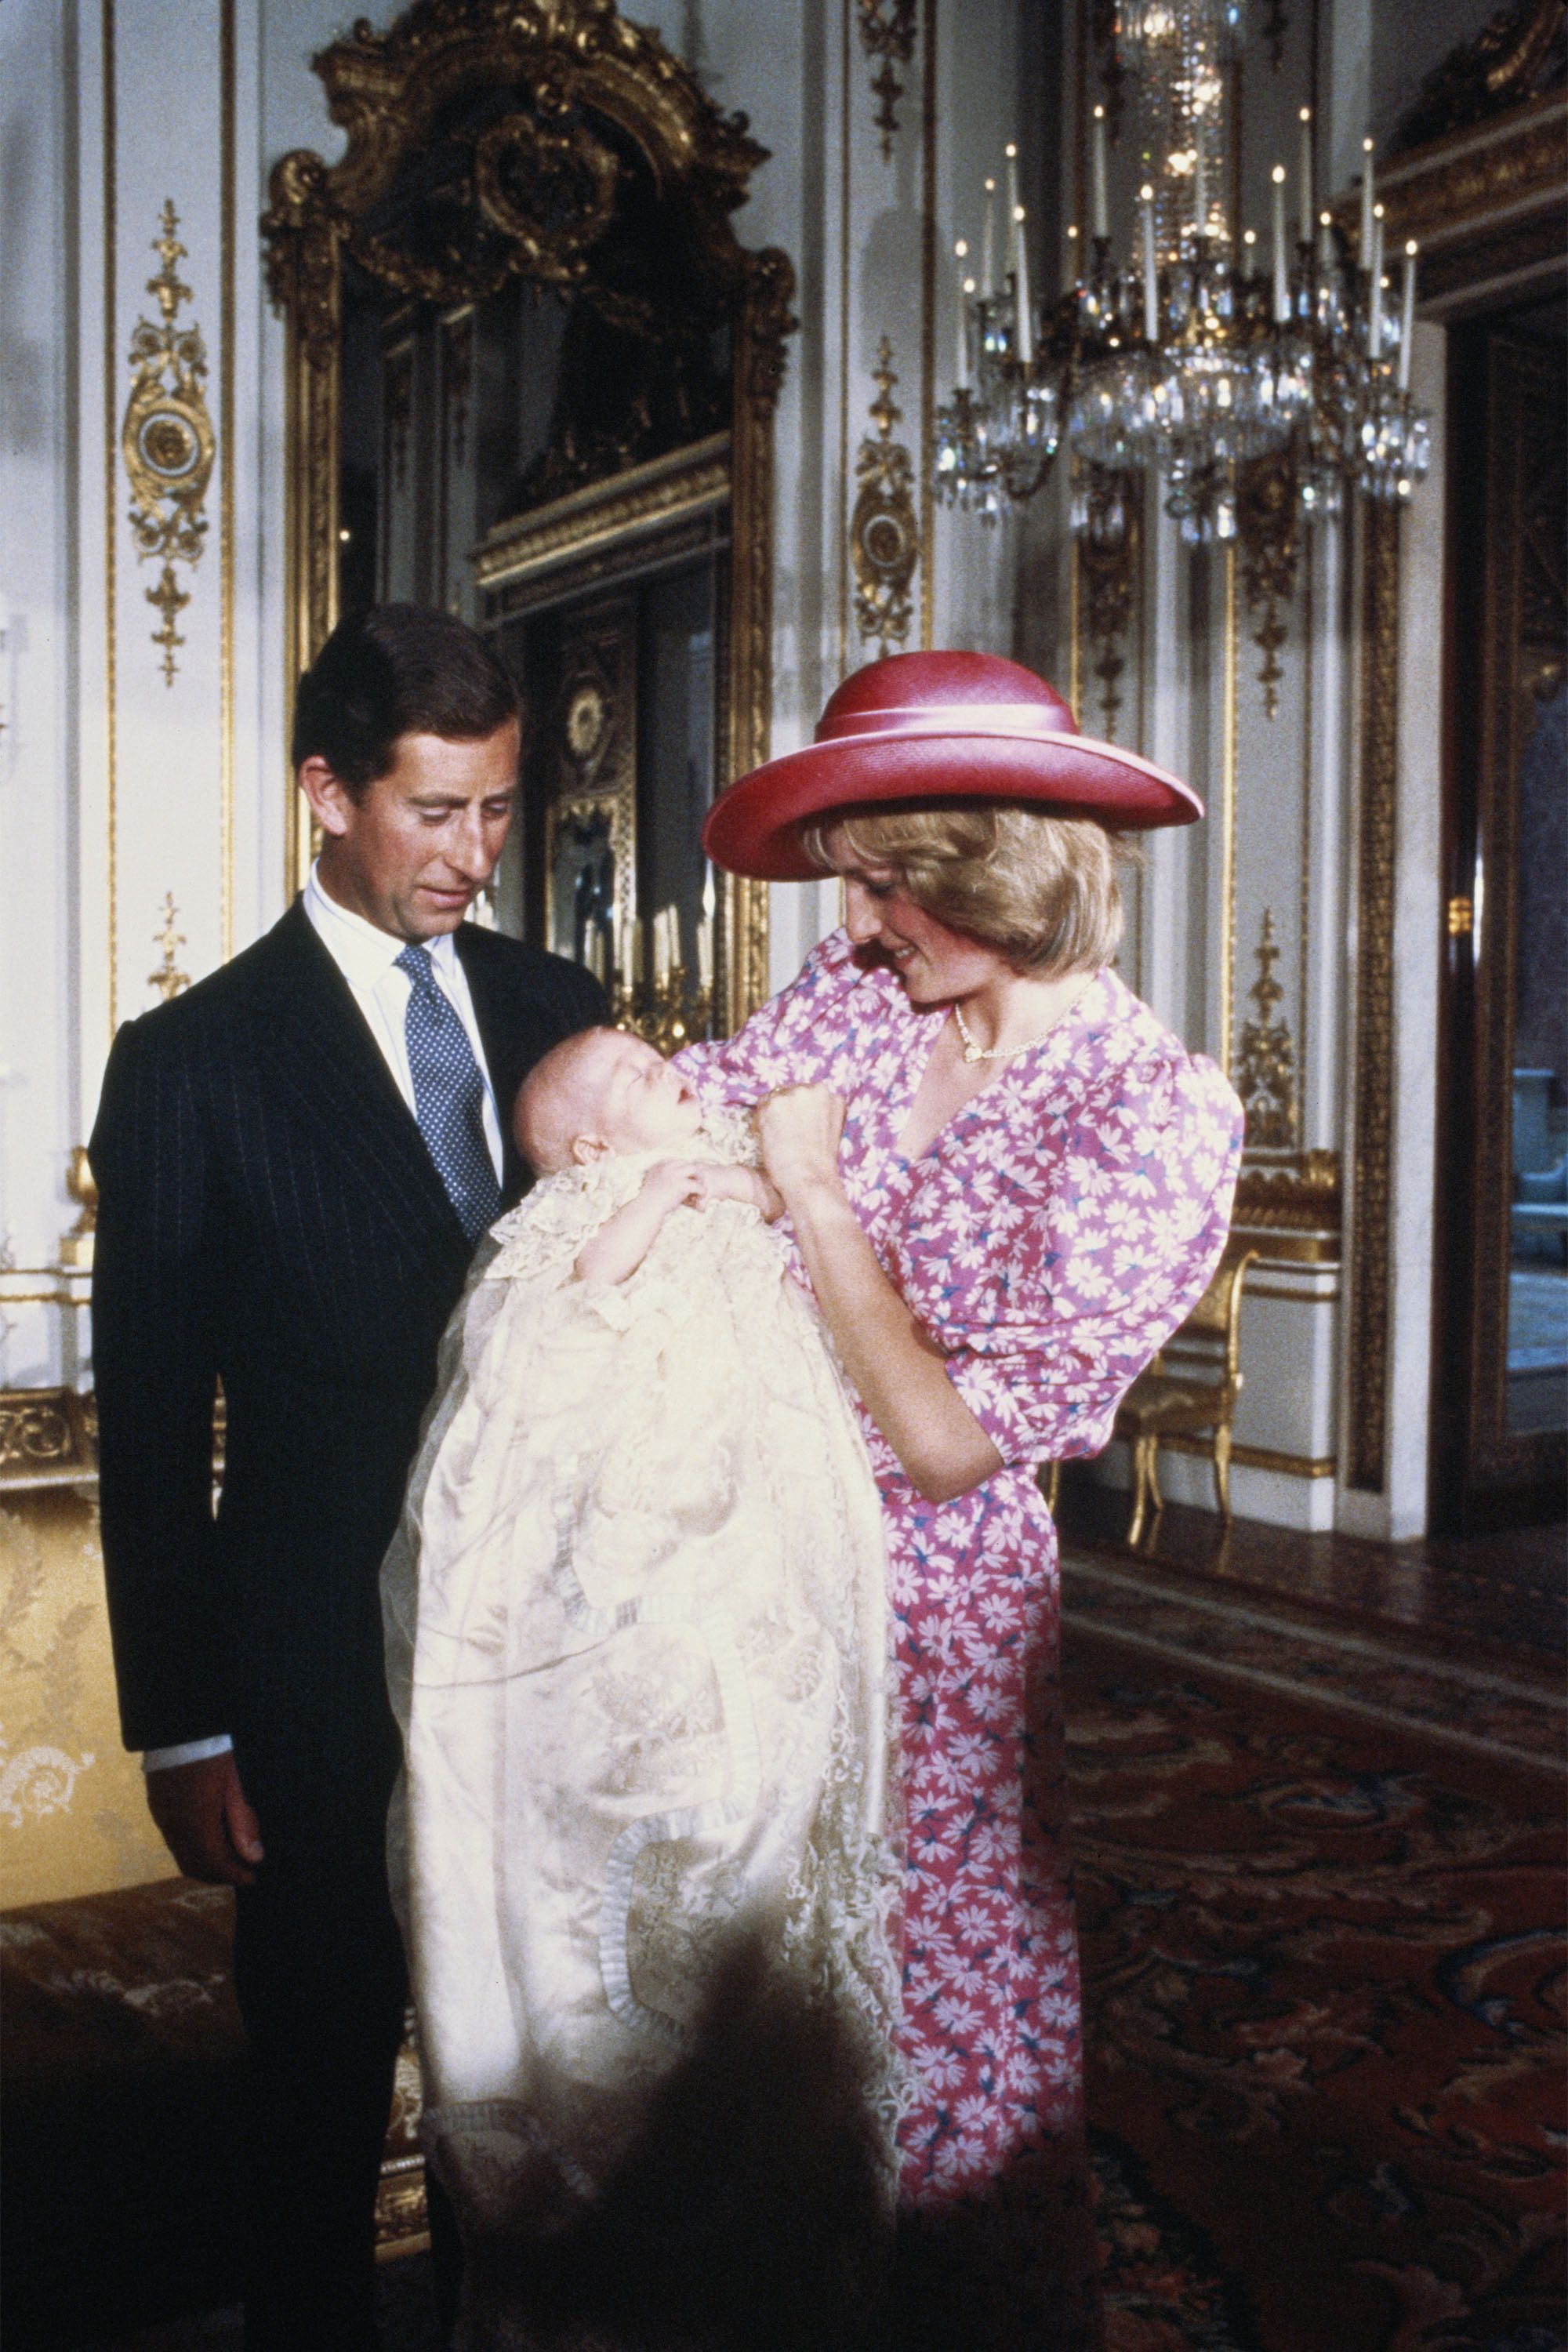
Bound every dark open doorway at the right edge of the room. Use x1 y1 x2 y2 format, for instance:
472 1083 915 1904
1432 296 1568 1534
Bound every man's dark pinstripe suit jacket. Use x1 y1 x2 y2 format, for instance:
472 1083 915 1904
89 906 604 1818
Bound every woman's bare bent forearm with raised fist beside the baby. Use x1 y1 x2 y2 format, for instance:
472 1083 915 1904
757 1087 1001 1503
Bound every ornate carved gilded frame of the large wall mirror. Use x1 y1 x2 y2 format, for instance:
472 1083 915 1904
261 0 794 1028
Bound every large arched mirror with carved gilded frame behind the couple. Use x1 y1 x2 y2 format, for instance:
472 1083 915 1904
263 0 792 1047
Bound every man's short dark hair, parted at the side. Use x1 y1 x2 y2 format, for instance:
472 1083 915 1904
294 604 520 793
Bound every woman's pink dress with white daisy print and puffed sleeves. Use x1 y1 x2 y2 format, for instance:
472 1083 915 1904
682 931 1241 2345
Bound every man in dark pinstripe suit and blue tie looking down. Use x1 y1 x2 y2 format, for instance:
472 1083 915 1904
92 604 607 2352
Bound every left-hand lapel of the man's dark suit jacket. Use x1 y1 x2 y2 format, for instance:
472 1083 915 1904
241 901 468 1251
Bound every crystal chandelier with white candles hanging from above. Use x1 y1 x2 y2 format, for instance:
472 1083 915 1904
933 0 1432 543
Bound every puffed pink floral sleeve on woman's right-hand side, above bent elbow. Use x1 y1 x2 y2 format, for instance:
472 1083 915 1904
938 1058 1241 1463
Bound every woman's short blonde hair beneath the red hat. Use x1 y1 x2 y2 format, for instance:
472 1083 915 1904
801 800 1138 974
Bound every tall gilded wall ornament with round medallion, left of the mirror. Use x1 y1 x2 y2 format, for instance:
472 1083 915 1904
120 202 216 687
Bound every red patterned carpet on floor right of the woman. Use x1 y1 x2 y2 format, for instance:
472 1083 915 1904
1065 1562 1568 2352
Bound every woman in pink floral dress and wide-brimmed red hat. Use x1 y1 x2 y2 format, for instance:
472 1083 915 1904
684 654 1241 2352
